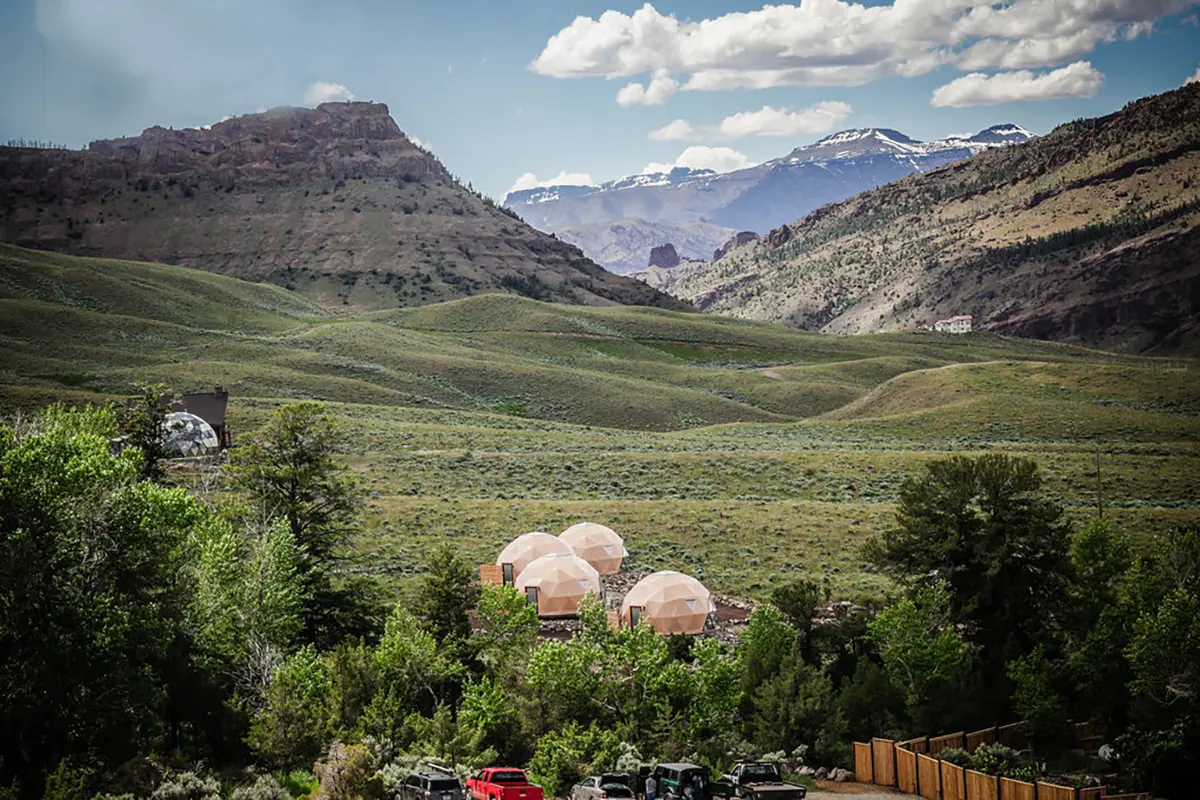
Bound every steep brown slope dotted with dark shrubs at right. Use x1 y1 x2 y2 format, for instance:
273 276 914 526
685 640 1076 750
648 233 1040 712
652 84 1200 354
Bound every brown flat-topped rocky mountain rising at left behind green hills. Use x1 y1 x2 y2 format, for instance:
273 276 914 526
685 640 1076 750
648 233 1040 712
0 103 685 308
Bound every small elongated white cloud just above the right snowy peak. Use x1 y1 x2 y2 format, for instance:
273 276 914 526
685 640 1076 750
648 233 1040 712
929 61 1104 108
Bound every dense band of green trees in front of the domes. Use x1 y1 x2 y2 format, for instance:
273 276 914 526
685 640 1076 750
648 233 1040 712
0 410 1200 800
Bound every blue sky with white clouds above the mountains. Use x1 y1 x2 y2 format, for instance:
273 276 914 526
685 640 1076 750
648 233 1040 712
0 0 1200 199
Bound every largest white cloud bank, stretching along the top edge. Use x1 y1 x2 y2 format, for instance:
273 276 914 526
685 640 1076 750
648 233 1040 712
532 0 1200 92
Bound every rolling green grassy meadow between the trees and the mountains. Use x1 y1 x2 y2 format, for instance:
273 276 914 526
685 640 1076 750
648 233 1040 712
0 246 1200 604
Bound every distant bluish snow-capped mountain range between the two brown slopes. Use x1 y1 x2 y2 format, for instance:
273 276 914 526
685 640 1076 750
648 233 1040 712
504 124 1032 273
